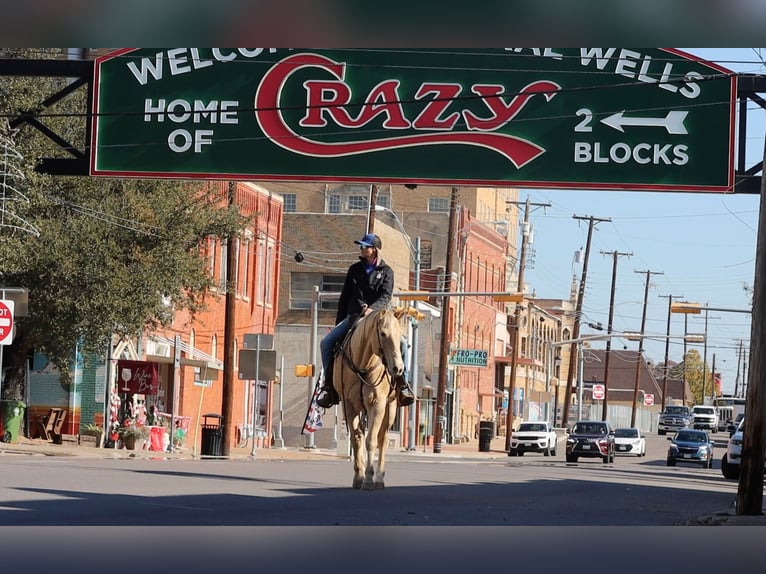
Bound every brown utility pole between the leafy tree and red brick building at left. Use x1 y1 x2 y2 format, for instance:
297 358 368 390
221 181 237 456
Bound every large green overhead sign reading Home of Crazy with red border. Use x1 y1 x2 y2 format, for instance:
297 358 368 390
91 48 736 192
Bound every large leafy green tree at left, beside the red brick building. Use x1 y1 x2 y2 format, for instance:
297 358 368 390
0 49 247 398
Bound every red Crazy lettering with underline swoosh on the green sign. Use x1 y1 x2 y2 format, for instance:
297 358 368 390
255 54 561 168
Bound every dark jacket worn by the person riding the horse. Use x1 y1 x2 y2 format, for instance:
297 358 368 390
335 257 394 325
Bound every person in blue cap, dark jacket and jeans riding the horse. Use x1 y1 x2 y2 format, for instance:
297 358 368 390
317 233 415 408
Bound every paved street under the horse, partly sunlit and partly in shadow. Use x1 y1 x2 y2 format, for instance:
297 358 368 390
0 437 748 526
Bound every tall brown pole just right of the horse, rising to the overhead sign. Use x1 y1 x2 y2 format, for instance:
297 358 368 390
434 187 460 454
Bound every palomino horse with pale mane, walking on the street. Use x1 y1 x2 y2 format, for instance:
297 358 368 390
333 309 406 490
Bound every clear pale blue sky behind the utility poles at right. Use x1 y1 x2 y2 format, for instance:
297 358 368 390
519 48 766 392
